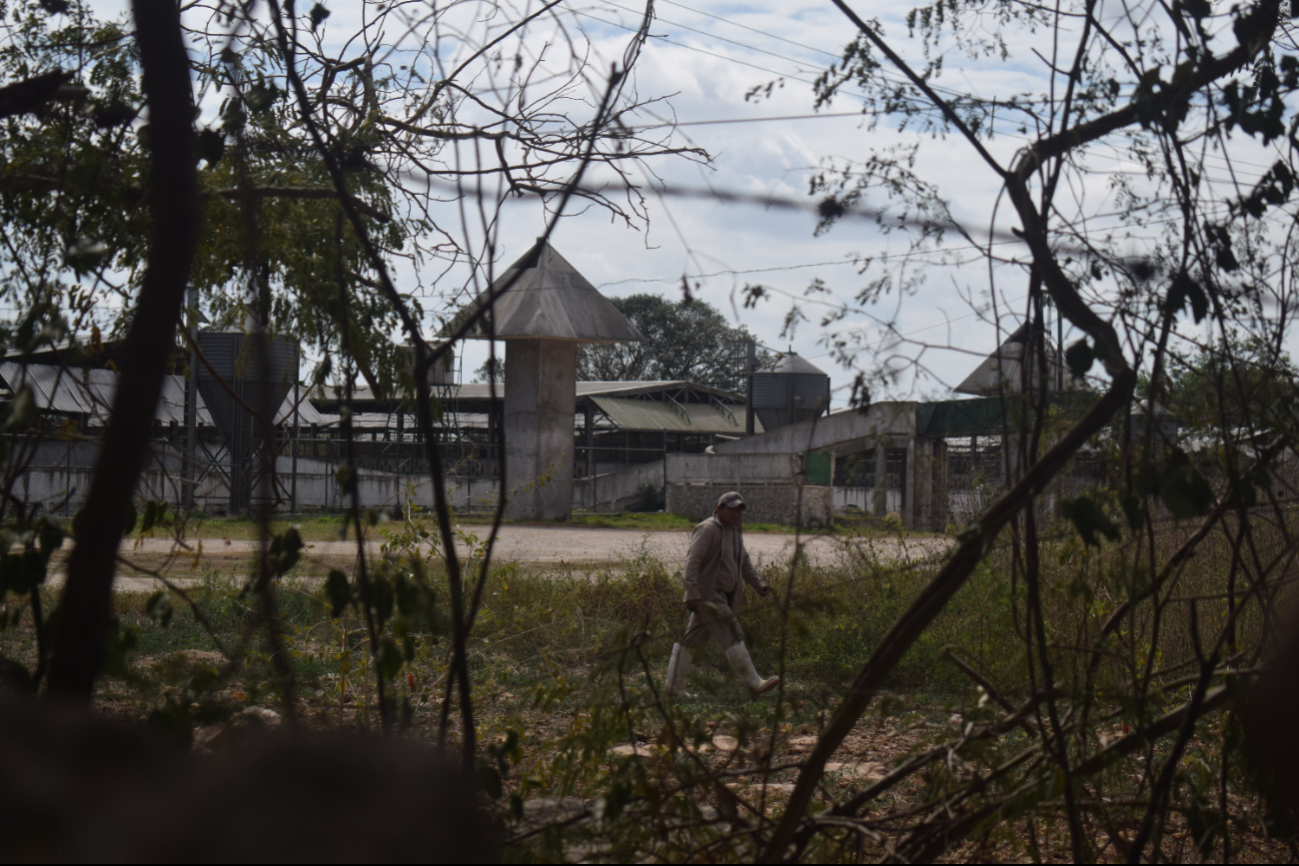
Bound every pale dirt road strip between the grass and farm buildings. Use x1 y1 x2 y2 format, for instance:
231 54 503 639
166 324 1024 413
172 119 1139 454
51 526 951 592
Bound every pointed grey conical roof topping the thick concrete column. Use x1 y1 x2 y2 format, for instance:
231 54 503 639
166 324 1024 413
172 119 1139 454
475 238 644 343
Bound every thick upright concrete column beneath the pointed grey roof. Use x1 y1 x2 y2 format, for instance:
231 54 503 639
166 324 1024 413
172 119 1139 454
503 340 577 521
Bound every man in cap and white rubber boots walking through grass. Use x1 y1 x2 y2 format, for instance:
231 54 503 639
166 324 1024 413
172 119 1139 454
668 491 781 696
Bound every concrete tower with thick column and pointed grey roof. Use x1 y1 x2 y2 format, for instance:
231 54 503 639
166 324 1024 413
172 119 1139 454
477 238 644 521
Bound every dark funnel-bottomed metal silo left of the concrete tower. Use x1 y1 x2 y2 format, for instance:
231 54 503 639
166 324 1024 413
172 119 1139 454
195 327 297 513
